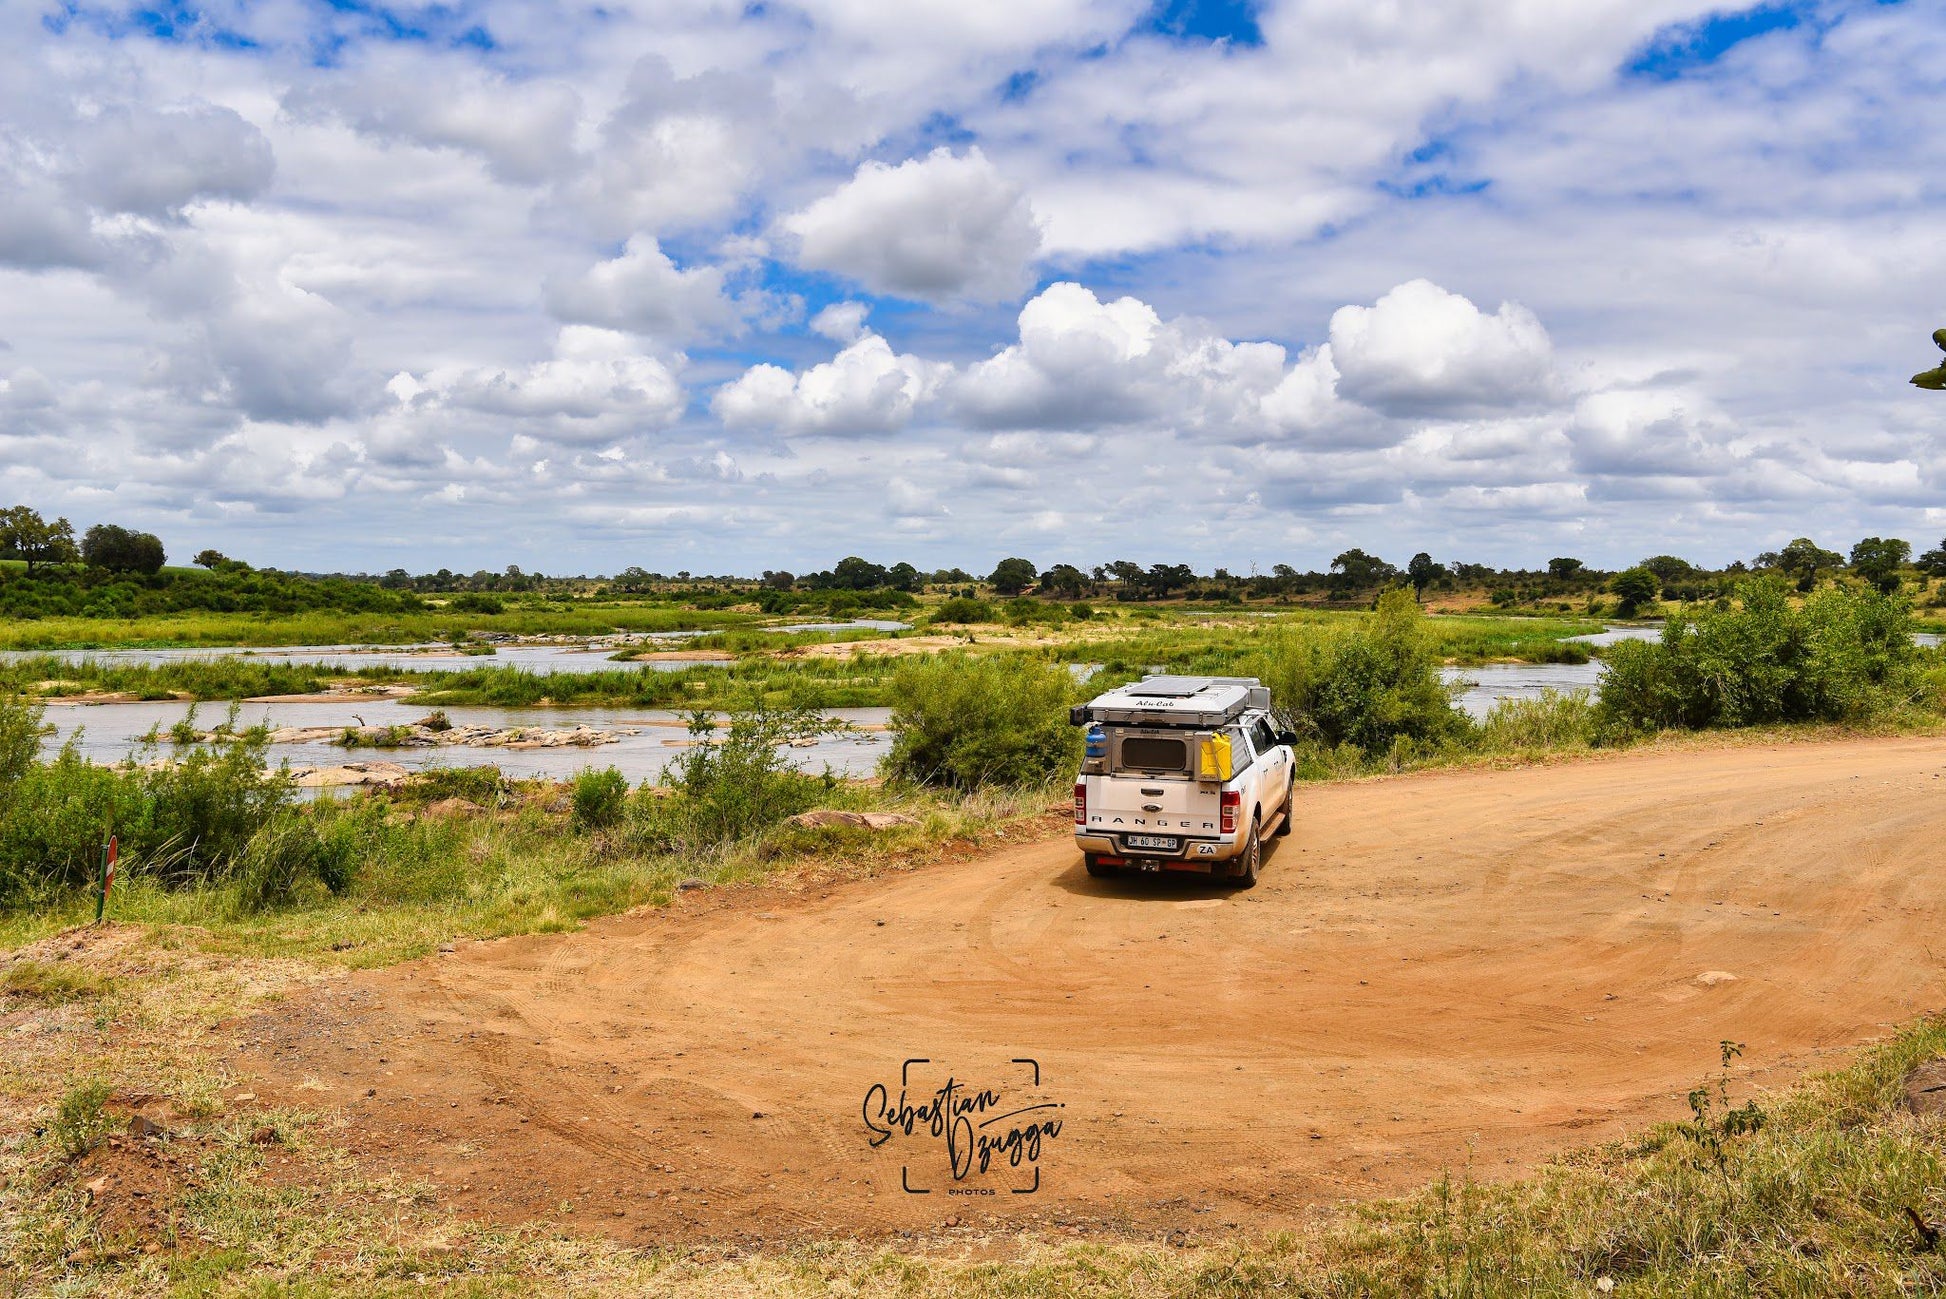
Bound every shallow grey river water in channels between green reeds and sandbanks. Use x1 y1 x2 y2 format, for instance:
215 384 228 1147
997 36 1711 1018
26 622 1940 782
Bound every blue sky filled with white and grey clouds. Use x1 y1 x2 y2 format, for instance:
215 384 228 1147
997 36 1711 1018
0 0 1946 572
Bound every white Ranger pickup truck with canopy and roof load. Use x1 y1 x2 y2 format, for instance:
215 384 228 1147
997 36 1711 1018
1068 677 1296 889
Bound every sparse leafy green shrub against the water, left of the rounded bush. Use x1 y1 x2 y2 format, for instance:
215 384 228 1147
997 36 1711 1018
636 704 841 852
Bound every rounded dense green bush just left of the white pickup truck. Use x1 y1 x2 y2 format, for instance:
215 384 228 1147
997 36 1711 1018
885 655 1080 790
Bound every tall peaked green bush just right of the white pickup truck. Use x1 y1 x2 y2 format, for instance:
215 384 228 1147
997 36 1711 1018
1255 587 1471 760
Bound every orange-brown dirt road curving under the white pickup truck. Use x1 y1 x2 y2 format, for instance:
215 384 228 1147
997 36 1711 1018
243 741 1946 1241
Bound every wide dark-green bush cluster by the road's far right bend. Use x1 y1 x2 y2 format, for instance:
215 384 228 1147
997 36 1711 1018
1600 576 1925 729
